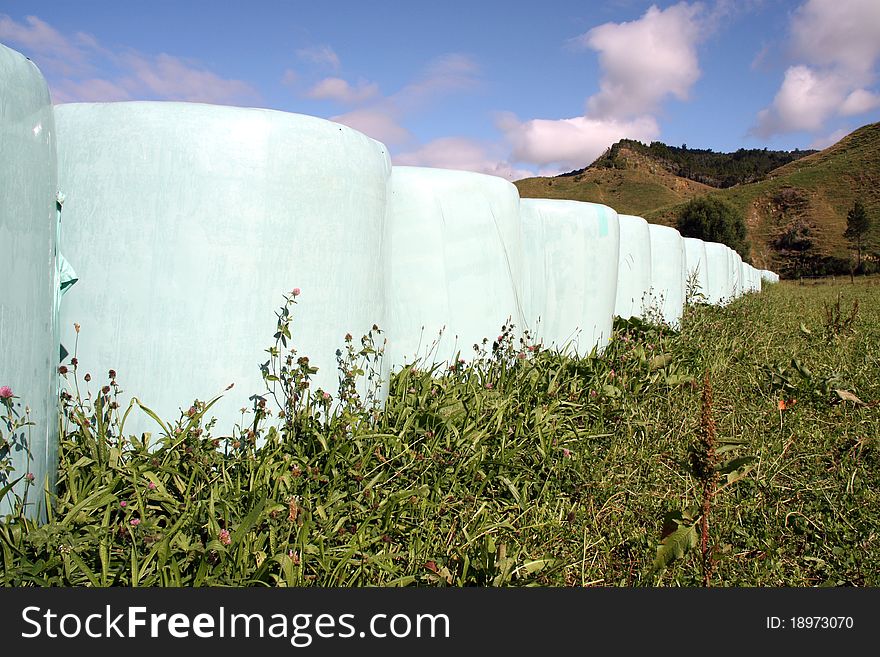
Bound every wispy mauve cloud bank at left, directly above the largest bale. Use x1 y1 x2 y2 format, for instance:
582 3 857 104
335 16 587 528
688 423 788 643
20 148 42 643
0 15 259 104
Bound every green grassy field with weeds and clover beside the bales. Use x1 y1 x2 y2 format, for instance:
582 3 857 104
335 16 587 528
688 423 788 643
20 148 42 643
0 278 880 587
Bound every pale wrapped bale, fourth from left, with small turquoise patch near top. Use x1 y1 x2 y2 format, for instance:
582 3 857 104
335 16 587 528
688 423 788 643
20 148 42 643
520 199 620 356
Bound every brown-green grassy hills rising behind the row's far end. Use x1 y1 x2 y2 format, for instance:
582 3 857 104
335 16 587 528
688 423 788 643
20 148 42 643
515 123 880 276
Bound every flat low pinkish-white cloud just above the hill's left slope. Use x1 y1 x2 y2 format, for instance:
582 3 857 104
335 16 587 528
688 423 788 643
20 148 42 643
498 115 660 170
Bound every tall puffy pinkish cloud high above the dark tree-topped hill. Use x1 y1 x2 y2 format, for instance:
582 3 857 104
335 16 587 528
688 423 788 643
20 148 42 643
577 2 705 120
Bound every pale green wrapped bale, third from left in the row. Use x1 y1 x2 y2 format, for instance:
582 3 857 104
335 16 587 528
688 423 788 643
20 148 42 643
383 166 523 369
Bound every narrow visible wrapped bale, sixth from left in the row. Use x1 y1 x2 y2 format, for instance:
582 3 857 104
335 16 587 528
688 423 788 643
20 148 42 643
649 224 685 326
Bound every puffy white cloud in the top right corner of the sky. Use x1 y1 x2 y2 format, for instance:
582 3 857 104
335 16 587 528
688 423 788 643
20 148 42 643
752 0 880 136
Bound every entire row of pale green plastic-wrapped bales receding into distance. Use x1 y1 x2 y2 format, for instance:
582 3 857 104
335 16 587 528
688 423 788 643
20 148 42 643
0 46 772 516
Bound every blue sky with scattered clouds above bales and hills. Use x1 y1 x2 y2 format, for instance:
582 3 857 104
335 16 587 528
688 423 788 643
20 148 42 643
0 0 880 180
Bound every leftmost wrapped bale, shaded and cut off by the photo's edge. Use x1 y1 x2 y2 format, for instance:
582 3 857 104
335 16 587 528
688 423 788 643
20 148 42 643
0 45 58 518
